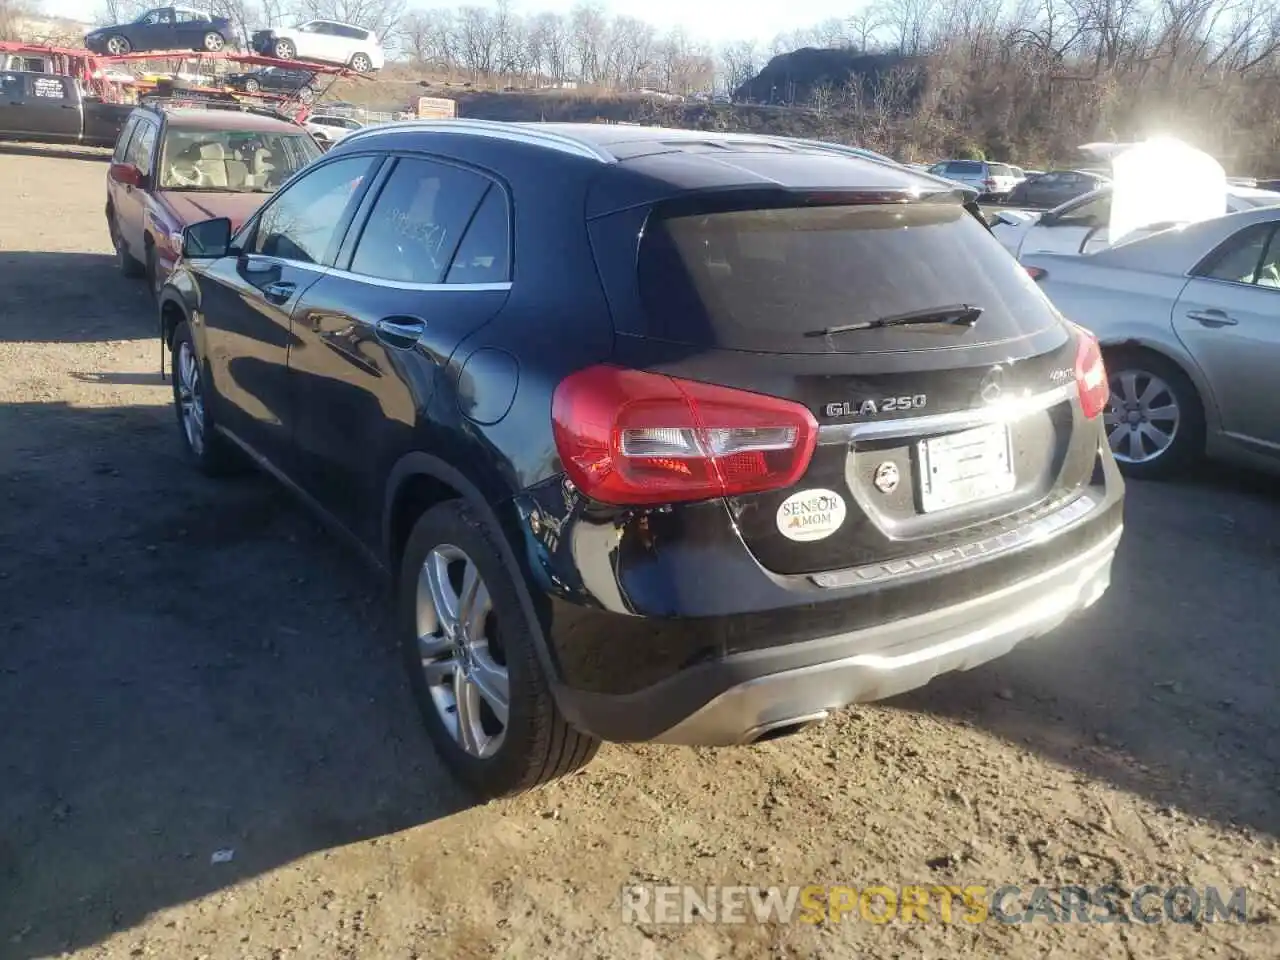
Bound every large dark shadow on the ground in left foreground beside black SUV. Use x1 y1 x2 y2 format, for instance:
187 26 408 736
0 403 467 957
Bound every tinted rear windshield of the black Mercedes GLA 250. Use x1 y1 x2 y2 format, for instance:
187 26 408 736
639 202 1055 353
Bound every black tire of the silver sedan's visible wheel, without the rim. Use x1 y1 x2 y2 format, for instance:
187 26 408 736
1103 347 1204 480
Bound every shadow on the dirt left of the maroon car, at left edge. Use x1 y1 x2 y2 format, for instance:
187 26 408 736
0 250 156 343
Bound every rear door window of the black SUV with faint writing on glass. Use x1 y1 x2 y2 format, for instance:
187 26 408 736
351 160 489 283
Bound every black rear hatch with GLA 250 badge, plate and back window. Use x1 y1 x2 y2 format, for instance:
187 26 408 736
593 192 1097 573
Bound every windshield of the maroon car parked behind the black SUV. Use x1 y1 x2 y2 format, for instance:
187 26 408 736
160 128 320 193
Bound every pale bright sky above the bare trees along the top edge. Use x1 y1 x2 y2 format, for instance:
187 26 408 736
42 0 865 45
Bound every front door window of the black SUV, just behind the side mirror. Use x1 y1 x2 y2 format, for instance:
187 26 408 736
252 156 374 264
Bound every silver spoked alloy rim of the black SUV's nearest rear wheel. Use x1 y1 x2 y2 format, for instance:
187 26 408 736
416 544 511 759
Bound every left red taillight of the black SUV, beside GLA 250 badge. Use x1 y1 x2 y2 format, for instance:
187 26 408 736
552 366 818 504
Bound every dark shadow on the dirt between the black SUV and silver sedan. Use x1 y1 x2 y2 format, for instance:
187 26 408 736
893 467 1280 836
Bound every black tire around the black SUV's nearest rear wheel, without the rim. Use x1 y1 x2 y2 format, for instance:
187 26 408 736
397 500 599 799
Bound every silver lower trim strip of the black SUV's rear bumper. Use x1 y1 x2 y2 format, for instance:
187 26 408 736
561 526 1121 746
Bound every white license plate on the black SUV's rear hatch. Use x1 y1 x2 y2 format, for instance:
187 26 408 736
916 424 1016 513
